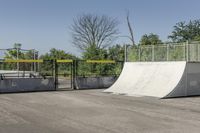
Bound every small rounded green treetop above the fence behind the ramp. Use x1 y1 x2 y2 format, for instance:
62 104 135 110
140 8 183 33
139 33 162 45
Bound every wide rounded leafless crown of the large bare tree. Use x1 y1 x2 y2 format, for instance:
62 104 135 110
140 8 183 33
71 14 118 51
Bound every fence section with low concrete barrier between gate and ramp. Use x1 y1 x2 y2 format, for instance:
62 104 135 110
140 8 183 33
75 60 123 89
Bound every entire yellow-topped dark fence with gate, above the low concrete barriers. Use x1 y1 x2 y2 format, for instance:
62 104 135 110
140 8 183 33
0 59 124 90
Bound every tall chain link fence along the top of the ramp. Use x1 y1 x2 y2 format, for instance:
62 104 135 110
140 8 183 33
127 42 200 62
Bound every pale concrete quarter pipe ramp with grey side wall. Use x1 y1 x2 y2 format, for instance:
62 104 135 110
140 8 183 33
104 61 200 98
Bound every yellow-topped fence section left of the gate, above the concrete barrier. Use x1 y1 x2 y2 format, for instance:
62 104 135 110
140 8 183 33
0 60 54 78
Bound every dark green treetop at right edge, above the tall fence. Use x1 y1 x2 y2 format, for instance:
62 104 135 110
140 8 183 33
168 19 200 42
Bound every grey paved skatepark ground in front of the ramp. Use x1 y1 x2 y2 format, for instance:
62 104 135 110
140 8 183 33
0 89 200 133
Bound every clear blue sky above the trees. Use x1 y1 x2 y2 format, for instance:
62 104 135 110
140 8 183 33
0 0 200 54
